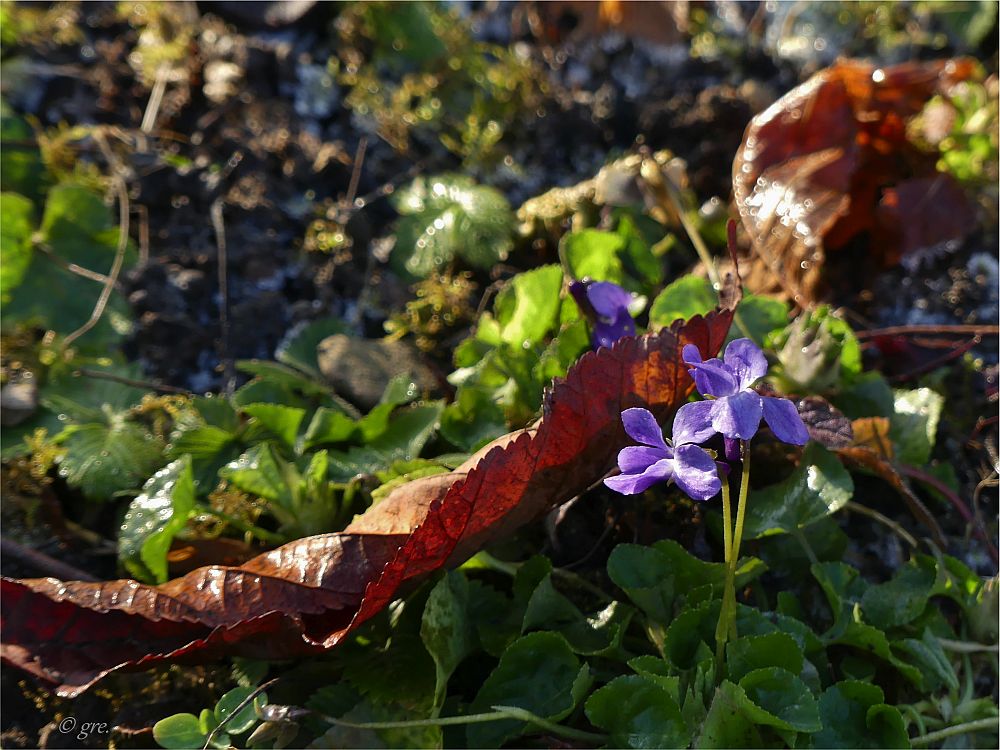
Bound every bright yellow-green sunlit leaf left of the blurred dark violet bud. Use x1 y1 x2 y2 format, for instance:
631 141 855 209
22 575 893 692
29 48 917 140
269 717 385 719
494 266 563 348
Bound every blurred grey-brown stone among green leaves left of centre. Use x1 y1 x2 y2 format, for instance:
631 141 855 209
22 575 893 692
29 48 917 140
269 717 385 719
316 333 438 411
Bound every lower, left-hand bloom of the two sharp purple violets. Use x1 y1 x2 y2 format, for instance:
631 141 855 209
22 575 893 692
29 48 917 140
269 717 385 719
604 409 722 500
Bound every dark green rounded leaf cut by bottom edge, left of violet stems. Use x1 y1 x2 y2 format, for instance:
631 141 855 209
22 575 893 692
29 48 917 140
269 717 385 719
586 675 691 748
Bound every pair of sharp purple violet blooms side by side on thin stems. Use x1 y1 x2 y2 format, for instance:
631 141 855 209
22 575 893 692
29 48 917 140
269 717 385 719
604 339 809 500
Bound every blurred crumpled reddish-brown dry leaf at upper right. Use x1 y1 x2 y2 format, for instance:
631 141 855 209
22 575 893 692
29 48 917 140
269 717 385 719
733 60 975 306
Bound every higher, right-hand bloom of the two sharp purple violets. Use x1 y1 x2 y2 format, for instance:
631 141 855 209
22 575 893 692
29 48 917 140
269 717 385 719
674 339 809 445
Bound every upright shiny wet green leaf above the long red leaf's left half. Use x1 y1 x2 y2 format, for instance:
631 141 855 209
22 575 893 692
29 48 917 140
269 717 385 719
118 457 195 583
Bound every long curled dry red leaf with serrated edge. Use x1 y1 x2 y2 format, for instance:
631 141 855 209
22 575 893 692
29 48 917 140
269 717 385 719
0 282 739 696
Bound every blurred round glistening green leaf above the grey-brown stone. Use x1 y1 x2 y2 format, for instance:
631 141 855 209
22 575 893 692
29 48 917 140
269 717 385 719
393 174 514 278
